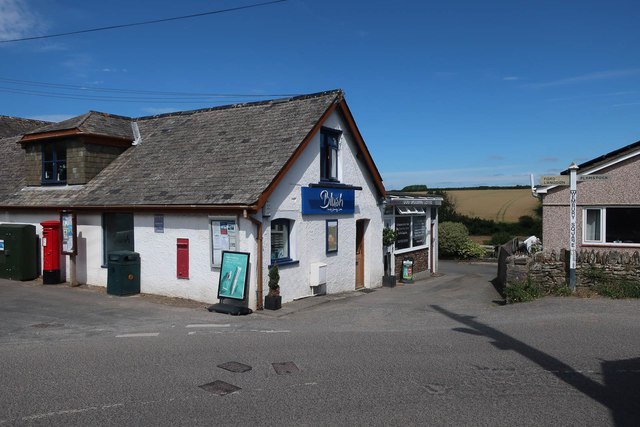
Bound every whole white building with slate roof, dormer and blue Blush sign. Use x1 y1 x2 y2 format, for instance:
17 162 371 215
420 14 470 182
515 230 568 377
0 90 385 309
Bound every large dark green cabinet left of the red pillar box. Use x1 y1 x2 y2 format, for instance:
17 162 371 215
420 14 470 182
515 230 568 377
0 224 39 280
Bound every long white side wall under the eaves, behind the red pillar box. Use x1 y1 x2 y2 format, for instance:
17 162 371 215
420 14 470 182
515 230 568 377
0 212 257 308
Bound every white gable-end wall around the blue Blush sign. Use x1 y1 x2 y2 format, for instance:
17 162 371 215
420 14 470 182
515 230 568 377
263 112 384 302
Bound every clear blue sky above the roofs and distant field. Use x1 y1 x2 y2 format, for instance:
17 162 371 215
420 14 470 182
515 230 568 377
0 0 640 189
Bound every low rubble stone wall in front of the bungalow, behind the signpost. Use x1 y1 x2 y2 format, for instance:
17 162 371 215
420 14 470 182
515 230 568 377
500 249 640 290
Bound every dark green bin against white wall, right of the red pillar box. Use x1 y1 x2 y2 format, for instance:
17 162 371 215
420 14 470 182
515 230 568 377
107 251 140 295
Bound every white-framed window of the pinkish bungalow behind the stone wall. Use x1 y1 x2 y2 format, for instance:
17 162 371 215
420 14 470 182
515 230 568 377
582 207 640 244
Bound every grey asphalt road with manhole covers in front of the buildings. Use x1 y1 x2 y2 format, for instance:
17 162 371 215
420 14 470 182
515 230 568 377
0 262 640 425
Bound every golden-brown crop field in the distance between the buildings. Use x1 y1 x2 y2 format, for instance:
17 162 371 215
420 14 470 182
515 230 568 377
446 188 539 222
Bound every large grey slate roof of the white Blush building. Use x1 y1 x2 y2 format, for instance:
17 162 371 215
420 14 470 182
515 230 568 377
0 90 376 207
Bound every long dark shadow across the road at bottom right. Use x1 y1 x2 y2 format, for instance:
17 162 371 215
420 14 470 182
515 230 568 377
431 305 640 426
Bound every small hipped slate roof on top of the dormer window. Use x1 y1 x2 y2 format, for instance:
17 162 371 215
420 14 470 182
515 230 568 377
25 111 133 140
